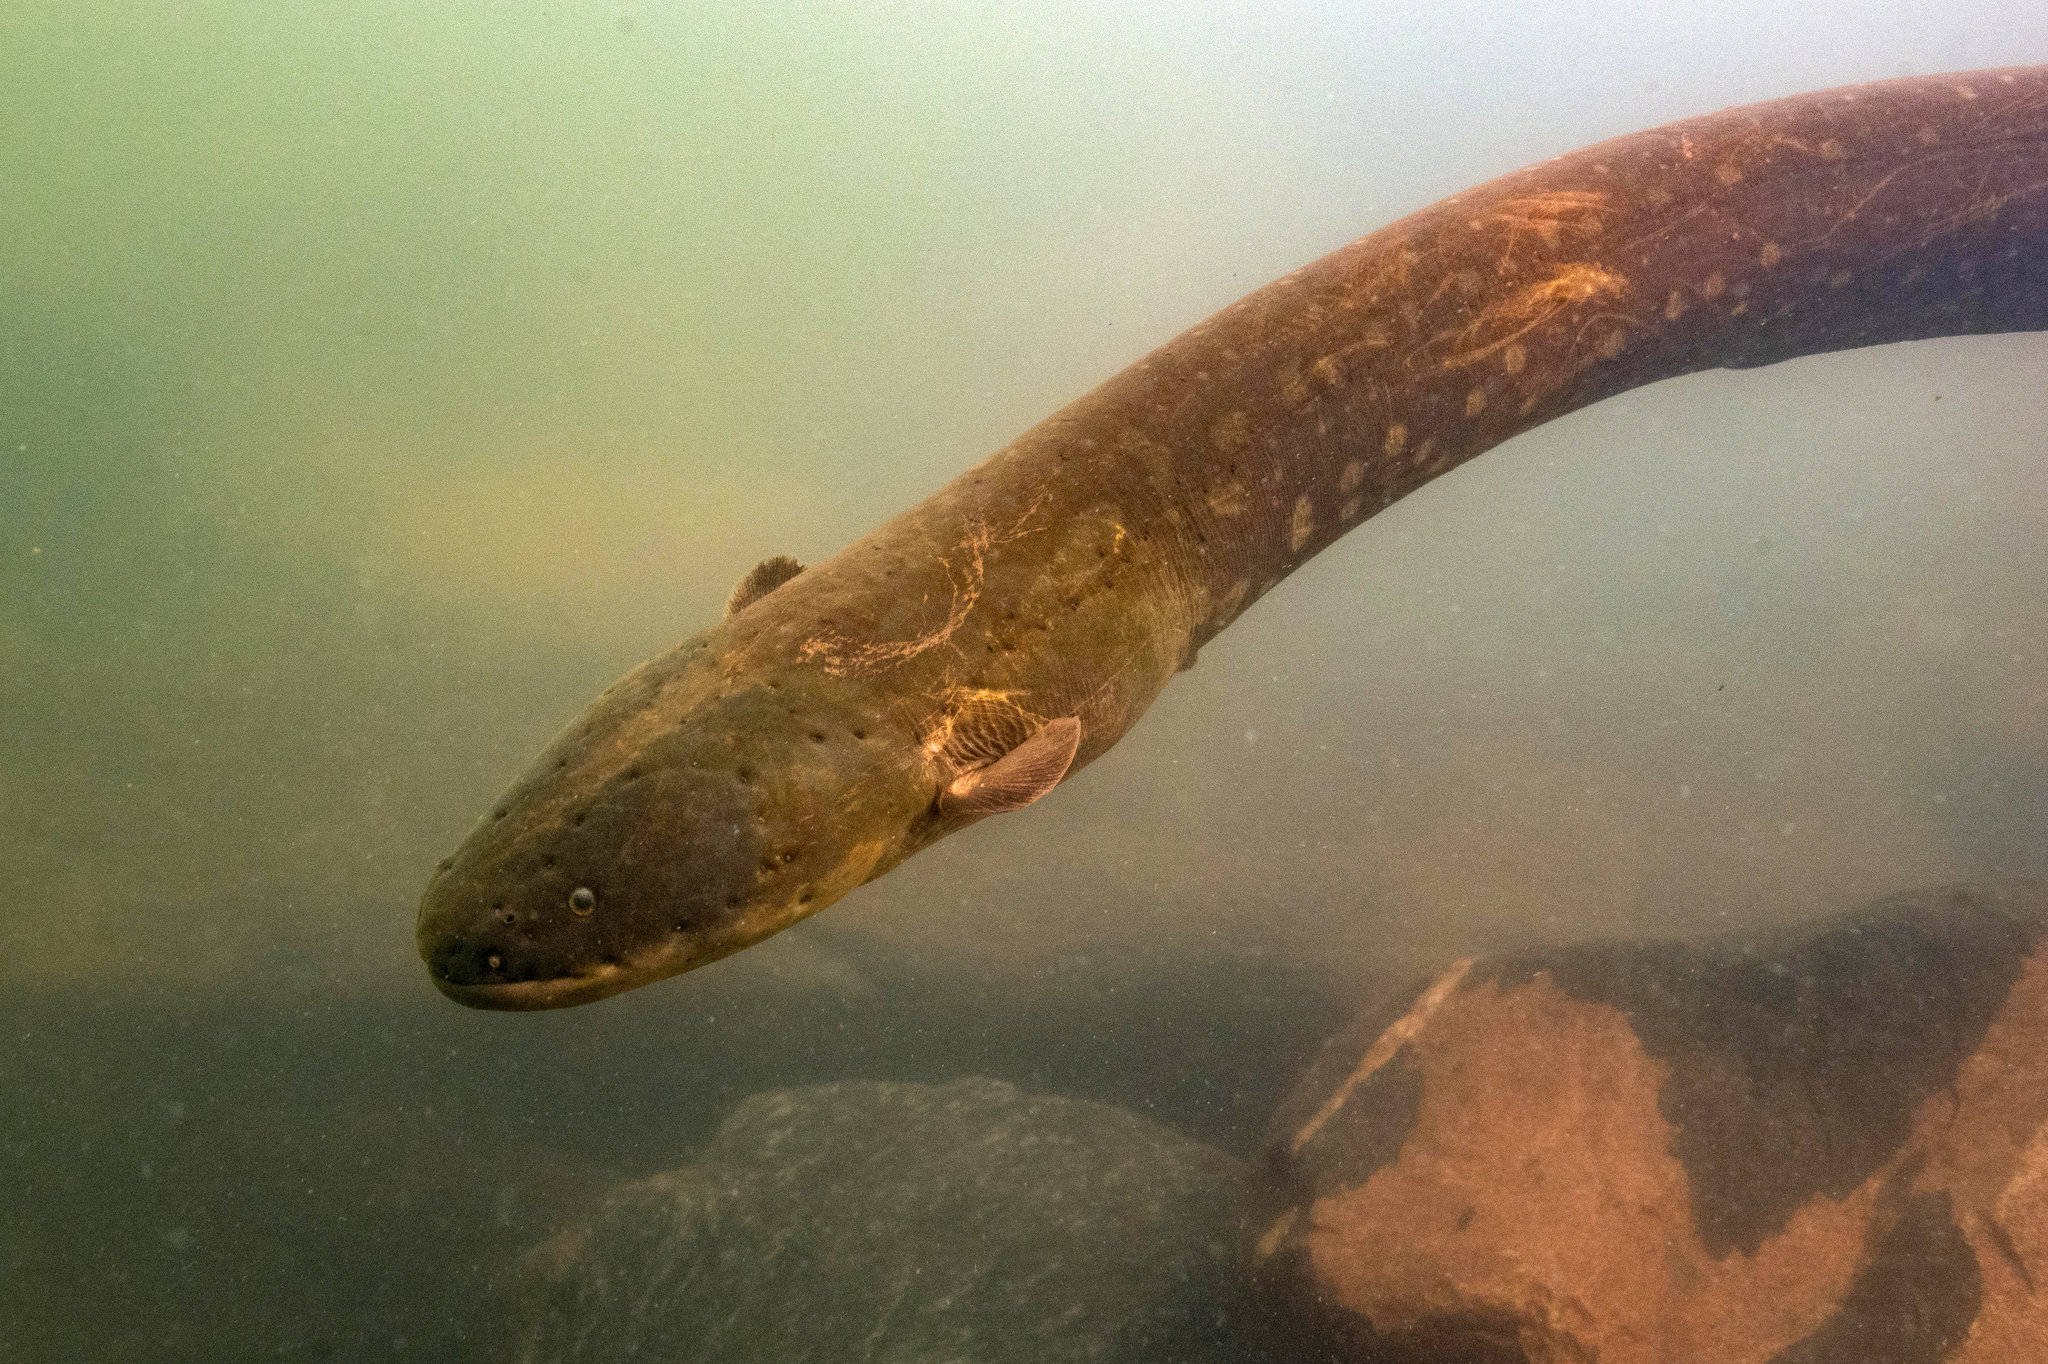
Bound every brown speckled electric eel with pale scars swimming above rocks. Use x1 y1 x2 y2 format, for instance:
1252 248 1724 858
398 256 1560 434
418 68 2048 1010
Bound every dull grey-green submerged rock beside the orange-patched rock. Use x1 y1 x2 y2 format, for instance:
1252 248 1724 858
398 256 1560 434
502 1079 1245 1364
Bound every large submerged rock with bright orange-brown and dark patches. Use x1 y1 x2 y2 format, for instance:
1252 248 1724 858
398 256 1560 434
1247 883 2048 1364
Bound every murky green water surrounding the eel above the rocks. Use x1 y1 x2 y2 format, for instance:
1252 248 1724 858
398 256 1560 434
0 0 2048 1360
